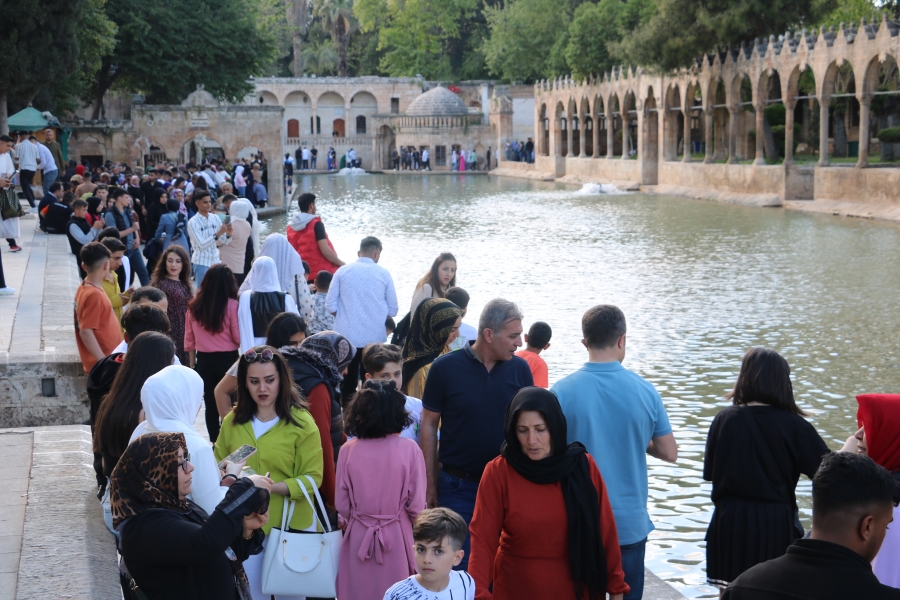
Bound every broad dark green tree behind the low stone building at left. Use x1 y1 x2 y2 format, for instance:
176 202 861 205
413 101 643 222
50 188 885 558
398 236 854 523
93 0 273 119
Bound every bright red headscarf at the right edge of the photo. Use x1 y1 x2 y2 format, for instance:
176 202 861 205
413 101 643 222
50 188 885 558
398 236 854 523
856 394 900 473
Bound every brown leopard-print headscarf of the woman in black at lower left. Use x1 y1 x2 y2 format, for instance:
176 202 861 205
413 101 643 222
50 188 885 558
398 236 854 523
109 433 190 528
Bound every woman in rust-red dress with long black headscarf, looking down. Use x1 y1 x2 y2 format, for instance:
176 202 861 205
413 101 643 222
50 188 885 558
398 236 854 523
469 387 629 600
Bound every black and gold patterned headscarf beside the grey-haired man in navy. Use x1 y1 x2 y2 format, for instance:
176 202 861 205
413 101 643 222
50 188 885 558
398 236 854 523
403 298 463 382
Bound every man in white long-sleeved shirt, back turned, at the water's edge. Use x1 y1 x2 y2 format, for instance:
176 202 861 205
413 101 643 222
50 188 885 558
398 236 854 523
325 236 399 406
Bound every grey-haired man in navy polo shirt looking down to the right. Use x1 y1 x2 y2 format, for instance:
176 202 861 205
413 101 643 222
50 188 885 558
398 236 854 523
419 298 534 569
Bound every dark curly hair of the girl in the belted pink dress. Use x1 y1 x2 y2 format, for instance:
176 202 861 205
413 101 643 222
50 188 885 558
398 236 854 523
344 379 413 440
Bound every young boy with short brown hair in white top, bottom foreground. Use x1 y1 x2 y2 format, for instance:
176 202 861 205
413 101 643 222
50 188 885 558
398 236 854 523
384 508 475 600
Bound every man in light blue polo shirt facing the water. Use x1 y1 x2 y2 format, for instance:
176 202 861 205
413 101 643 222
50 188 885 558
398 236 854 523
552 304 678 600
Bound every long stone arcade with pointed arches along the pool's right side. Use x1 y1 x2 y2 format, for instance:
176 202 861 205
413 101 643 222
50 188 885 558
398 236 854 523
520 17 900 204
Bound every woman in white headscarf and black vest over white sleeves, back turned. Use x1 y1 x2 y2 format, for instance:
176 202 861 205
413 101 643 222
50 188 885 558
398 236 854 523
238 256 302 353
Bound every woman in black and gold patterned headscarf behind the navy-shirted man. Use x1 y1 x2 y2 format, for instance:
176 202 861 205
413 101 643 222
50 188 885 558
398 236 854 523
402 298 465 398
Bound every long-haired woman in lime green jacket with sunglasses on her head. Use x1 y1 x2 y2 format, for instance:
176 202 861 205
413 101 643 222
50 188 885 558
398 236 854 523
215 346 323 600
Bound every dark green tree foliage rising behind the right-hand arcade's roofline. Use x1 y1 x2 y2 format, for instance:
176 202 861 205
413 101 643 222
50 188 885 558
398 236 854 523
611 0 837 71
